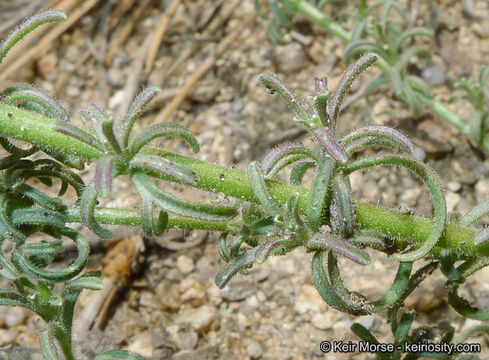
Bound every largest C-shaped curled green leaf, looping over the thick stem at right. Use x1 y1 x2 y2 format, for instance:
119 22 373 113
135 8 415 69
344 155 446 262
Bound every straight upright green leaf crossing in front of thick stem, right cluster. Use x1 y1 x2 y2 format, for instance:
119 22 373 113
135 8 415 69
306 156 334 231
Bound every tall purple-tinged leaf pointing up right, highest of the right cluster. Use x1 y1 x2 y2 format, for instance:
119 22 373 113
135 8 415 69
328 54 377 129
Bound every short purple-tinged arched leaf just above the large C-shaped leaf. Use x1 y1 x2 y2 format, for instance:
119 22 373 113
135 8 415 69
341 125 414 154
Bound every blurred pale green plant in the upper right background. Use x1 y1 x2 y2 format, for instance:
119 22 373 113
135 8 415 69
260 0 489 153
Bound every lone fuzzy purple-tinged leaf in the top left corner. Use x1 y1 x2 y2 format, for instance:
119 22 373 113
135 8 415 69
0 10 66 63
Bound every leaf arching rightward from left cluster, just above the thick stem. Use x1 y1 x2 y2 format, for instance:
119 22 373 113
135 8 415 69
130 124 200 154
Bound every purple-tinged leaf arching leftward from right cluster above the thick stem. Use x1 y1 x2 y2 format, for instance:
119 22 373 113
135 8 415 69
261 144 318 179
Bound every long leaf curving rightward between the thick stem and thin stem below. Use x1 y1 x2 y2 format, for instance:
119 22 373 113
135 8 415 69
131 172 237 221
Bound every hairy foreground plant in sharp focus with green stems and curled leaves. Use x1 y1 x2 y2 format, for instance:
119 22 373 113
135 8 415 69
0 7 489 360
